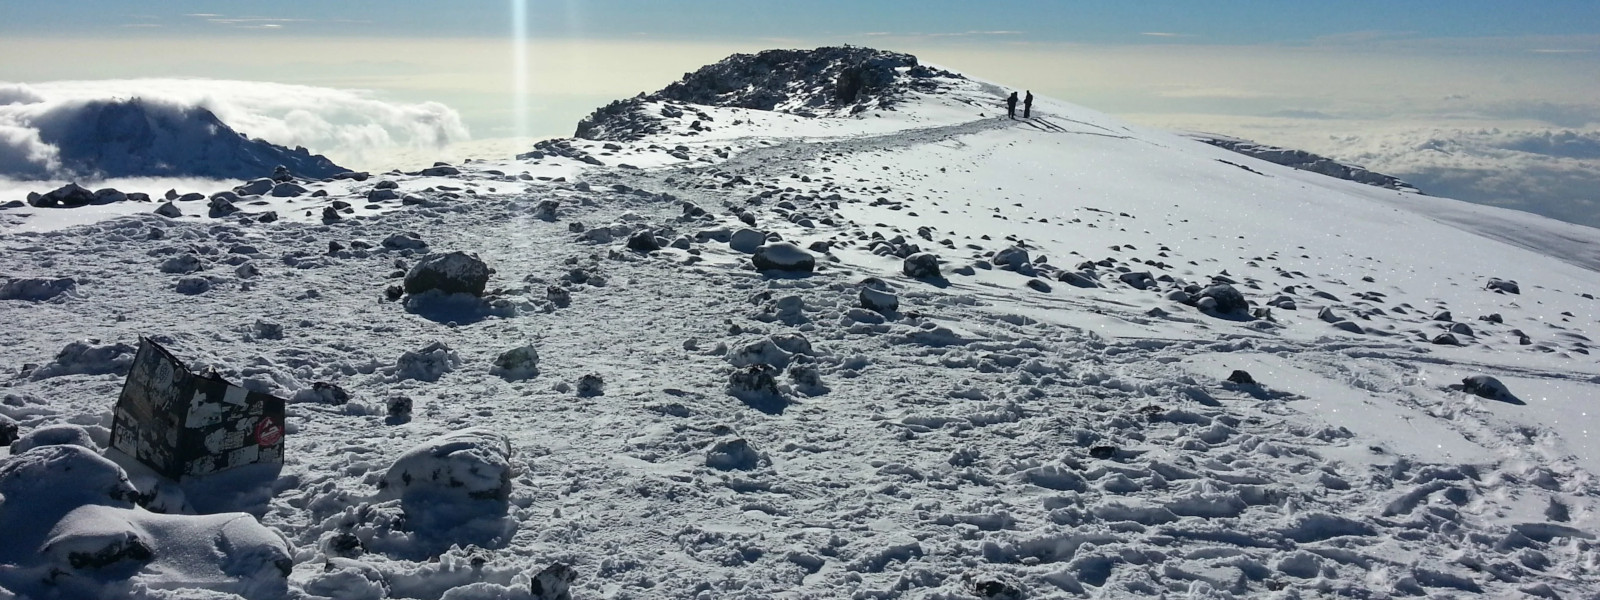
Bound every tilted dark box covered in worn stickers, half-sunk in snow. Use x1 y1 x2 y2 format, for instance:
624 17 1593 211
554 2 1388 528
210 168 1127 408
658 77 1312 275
110 338 283 480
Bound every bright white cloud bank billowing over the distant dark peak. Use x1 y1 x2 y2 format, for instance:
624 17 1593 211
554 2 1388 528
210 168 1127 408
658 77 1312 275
0 78 470 173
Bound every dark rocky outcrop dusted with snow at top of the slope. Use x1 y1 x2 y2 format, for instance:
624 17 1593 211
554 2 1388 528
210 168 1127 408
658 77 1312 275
574 46 962 141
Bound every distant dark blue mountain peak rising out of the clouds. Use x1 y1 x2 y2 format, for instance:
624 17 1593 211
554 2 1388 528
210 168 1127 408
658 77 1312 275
14 98 347 179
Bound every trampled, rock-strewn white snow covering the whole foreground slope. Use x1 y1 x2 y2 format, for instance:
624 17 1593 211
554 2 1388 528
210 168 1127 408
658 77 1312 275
0 49 1600 598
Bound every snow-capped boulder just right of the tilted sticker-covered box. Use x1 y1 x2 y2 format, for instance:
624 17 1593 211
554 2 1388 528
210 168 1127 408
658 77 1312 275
378 427 512 510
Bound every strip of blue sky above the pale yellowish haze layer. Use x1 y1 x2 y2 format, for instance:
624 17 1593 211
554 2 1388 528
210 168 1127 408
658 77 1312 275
9 0 1600 45
